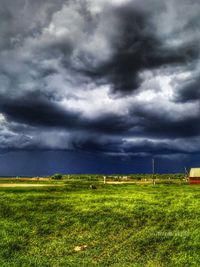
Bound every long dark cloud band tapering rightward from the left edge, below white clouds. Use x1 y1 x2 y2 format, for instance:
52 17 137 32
0 90 132 135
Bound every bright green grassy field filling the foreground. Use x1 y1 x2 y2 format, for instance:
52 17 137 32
0 179 200 267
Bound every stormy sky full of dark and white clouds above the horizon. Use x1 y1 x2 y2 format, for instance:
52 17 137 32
0 0 200 175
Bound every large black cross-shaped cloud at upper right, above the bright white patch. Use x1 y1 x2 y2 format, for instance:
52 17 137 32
88 3 198 94
